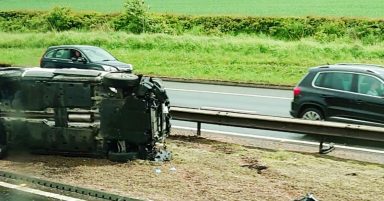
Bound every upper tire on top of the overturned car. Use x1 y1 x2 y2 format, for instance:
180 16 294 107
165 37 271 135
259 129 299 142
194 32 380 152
103 72 139 88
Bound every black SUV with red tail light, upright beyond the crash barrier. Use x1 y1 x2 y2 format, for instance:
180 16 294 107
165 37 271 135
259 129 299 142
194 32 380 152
290 64 384 125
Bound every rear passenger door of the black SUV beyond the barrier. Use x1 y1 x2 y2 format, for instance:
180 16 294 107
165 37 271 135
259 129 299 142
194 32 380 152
314 71 354 118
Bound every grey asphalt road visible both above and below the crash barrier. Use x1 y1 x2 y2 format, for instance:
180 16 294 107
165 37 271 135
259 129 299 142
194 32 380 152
164 82 384 153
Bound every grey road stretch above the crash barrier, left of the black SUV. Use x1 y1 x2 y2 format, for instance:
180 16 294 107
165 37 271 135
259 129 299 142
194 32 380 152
164 82 293 117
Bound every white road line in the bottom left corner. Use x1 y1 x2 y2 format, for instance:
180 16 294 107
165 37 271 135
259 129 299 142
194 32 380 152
0 181 85 201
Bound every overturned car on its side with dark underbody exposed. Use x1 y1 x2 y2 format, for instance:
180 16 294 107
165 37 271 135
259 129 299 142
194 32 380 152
0 68 171 161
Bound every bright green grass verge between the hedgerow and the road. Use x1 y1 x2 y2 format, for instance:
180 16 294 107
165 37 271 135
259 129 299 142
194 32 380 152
0 32 384 85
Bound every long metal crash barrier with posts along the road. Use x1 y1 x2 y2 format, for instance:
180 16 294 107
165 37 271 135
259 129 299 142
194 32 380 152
171 107 384 153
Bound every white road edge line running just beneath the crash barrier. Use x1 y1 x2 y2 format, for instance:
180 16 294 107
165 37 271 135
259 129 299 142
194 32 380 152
172 126 384 154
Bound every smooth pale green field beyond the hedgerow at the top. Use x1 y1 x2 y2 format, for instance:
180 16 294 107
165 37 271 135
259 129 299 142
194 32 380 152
0 0 384 18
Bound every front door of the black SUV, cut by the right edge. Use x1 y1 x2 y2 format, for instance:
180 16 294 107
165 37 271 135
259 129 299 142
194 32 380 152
351 74 384 123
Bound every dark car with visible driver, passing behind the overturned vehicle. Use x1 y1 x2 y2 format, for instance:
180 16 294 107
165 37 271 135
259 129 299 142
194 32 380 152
40 45 133 72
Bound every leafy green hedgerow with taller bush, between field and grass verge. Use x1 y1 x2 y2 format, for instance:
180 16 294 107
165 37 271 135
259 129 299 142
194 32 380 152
0 6 384 43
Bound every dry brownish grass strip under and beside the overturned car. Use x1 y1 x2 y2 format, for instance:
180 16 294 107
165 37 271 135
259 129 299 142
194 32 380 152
0 135 384 201
